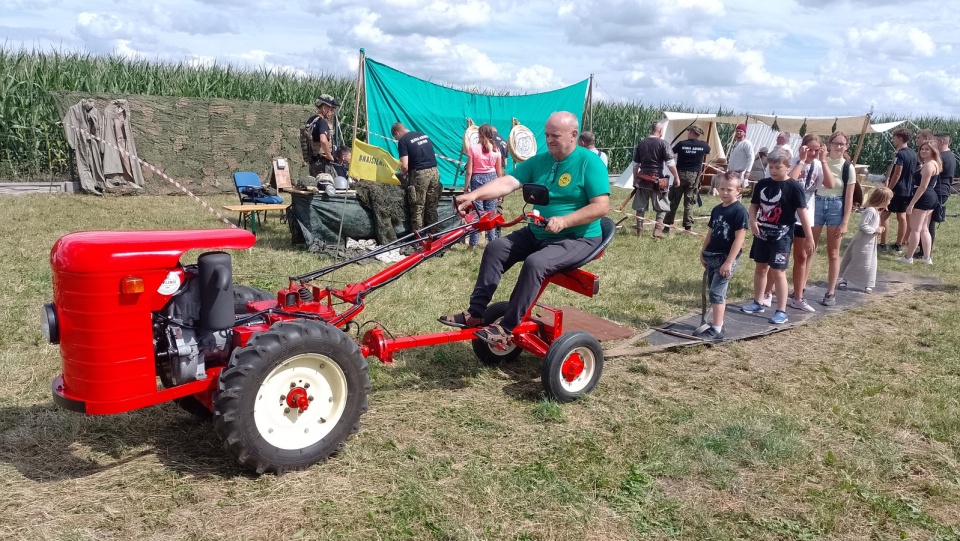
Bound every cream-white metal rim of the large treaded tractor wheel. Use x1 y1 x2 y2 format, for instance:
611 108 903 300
253 353 347 449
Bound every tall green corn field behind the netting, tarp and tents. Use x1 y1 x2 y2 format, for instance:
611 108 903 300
0 48 960 181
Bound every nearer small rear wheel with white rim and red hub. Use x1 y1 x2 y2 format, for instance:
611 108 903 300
540 331 603 403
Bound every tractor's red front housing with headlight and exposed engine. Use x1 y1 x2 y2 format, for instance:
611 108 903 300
41 229 256 415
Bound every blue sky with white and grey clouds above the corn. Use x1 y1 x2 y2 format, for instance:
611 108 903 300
0 0 960 117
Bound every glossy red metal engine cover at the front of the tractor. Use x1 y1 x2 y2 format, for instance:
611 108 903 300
50 229 256 414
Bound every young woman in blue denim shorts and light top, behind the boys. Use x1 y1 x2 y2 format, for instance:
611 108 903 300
812 131 857 306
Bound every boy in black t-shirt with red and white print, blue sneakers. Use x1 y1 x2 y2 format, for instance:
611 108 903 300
740 152 815 325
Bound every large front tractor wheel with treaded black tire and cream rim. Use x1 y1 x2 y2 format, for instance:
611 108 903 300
213 319 371 475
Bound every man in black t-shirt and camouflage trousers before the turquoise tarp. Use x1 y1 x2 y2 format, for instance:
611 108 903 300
390 122 443 231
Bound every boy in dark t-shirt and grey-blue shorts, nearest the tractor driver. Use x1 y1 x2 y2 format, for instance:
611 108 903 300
700 171 747 340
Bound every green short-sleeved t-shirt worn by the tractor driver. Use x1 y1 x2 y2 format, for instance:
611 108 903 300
511 146 610 240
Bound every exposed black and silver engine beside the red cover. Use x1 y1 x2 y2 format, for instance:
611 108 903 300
153 252 235 387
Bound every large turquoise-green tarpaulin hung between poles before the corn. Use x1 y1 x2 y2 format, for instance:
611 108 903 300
364 58 589 187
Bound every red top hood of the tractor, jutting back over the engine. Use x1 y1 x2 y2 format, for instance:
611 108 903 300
50 228 257 273
